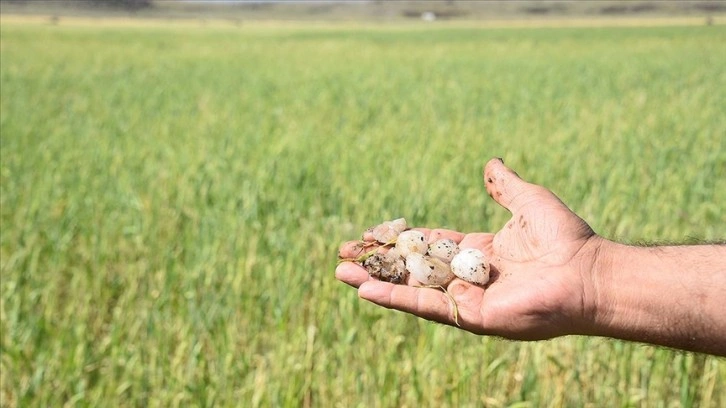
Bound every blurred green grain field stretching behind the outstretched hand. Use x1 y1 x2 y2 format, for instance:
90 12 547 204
0 2 726 407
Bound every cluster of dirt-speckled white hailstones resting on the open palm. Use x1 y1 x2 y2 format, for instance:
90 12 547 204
361 218 490 286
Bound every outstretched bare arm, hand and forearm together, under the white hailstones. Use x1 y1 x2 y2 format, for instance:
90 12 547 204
336 159 726 356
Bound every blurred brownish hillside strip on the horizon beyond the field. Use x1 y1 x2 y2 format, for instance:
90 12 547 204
0 0 726 21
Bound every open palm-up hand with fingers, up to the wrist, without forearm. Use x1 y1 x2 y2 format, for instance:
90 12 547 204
336 159 603 340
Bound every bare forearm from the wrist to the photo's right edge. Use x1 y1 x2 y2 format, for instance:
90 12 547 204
588 241 726 356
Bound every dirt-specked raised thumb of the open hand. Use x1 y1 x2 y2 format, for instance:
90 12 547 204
484 158 542 214
